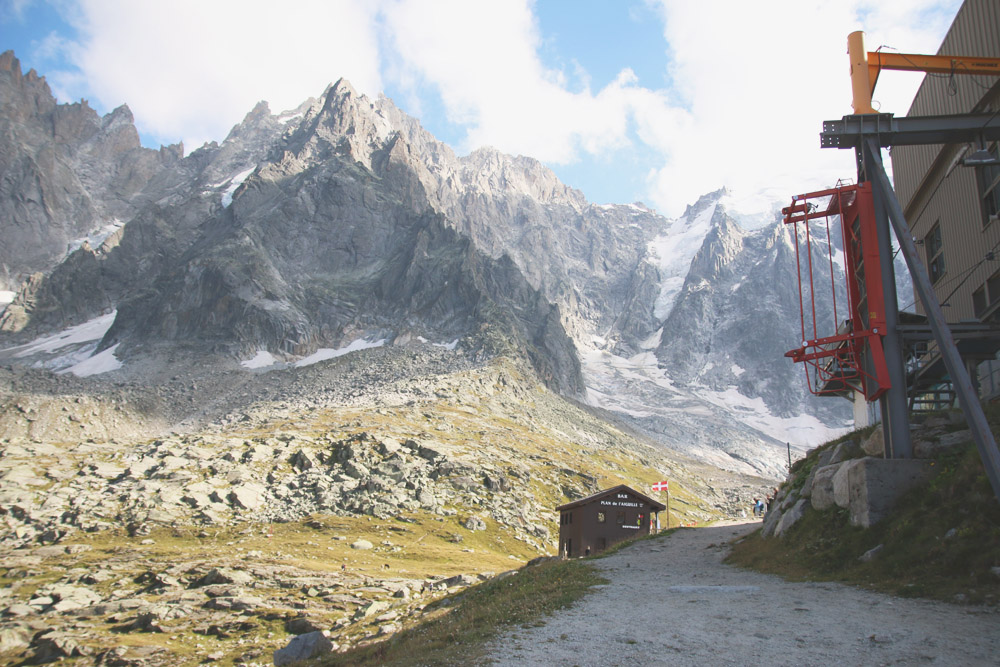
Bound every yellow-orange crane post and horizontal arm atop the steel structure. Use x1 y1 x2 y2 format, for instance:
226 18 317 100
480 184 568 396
847 31 1000 114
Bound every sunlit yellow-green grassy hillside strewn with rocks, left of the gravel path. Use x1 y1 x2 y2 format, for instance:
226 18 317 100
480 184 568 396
0 361 719 667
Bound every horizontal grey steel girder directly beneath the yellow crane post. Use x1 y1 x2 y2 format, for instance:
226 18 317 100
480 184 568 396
819 113 1000 148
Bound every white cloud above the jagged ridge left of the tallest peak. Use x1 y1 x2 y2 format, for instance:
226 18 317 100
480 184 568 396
62 0 381 150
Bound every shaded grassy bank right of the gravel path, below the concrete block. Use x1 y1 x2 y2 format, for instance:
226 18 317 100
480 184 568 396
728 410 1000 605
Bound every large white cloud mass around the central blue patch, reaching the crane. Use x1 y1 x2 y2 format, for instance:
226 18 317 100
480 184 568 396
376 0 959 215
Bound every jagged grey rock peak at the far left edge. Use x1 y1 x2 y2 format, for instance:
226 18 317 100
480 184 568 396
0 51 172 298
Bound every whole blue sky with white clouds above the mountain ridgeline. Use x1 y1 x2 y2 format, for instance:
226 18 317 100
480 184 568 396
0 0 962 216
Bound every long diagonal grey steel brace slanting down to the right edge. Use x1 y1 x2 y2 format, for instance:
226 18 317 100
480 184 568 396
864 137 1000 500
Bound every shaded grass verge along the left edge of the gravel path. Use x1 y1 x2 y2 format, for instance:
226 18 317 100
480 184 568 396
320 560 606 667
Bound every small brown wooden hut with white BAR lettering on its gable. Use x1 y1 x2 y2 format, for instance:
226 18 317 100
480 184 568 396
556 484 667 558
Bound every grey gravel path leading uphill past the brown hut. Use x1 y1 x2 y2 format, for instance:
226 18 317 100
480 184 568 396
490 522 1000 667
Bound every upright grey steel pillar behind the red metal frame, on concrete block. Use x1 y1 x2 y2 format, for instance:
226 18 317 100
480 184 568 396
858 143 913 459
